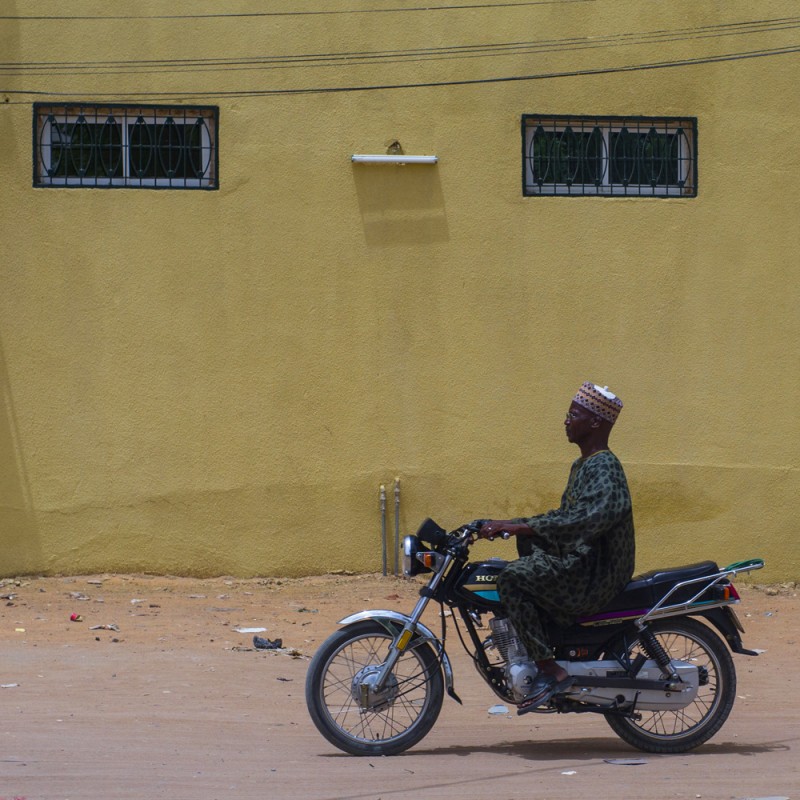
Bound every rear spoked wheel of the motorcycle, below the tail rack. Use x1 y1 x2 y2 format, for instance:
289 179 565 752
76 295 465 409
606 618 736 753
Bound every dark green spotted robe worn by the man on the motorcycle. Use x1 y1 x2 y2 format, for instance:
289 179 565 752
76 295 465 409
497 450 635 661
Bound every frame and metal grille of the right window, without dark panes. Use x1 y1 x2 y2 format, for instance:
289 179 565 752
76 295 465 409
521 114 698 199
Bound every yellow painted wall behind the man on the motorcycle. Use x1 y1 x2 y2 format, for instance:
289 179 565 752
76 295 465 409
0 0 800 581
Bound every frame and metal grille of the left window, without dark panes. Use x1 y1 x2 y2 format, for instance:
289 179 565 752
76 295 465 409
33 102 219 191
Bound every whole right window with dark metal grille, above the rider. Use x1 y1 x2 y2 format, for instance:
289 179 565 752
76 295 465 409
522 114 697 197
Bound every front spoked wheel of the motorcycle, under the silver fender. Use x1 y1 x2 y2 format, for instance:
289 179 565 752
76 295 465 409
306 621 444 756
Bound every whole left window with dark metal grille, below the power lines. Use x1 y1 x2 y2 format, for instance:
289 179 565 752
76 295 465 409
33 103 219 189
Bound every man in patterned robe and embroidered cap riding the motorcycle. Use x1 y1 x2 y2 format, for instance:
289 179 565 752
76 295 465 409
478 383 634 714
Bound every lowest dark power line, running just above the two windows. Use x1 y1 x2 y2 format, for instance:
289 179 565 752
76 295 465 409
0 45 800 102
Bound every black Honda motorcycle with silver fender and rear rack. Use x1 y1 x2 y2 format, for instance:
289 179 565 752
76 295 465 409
306 519 764 756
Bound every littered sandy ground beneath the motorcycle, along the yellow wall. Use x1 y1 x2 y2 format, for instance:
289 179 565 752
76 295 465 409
0 575 800 800
